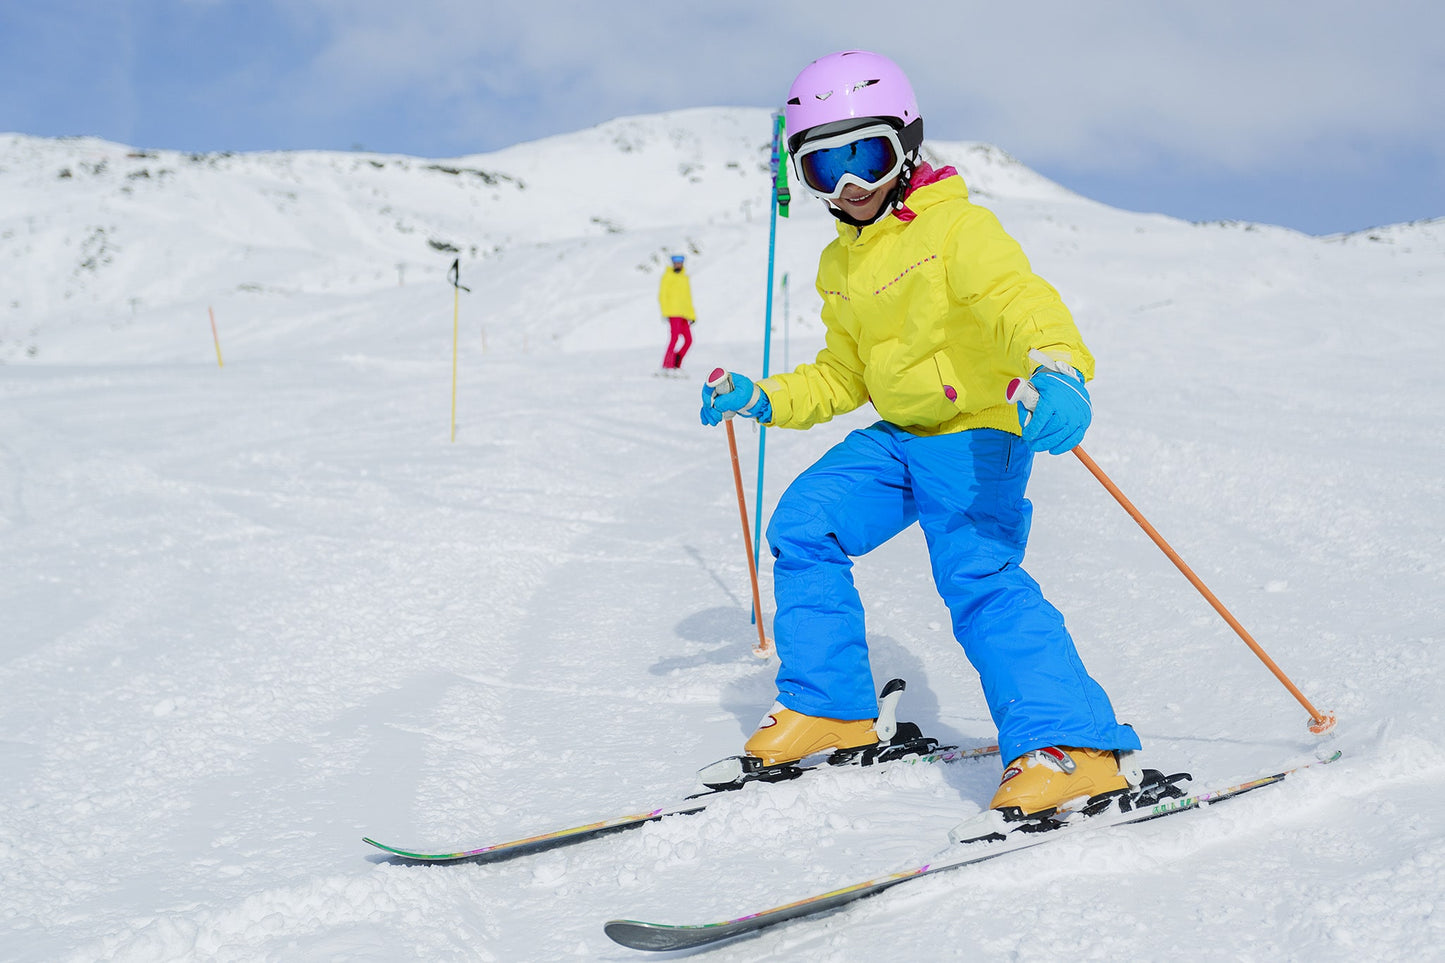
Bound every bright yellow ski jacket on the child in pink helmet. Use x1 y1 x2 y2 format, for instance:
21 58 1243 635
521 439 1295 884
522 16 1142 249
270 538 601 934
760 163 1094 435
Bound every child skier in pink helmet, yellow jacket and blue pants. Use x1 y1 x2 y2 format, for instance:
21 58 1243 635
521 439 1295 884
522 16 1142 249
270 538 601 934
702 51 1139 818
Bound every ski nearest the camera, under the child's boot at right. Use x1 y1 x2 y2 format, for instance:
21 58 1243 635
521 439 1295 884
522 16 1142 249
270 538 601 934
603 750 1341 950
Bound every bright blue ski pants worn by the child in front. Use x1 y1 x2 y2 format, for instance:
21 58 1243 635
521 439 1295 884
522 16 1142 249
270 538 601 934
767 422 1139 762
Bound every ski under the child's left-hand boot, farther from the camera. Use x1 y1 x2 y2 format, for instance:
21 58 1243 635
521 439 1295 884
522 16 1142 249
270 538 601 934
363 737 998 865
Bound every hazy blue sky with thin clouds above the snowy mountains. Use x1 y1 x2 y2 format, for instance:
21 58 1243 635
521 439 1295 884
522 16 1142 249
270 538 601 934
0 0 1445 234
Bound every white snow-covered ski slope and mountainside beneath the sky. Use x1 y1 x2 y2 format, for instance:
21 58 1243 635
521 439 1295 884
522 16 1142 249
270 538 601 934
0 110 1445 960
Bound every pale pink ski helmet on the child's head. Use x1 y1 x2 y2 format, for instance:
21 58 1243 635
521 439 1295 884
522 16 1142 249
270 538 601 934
783 51 923 152
